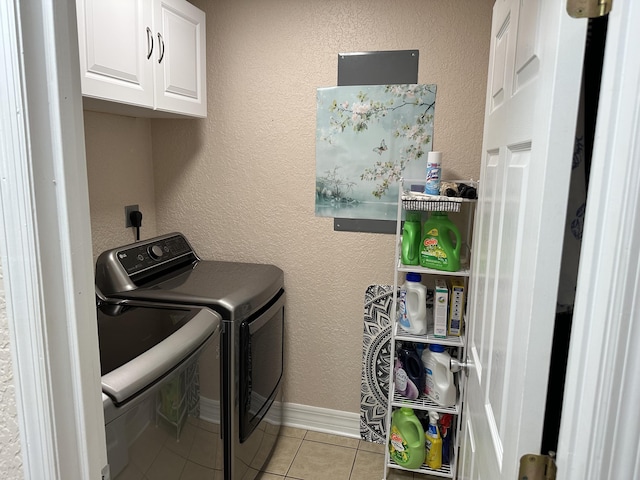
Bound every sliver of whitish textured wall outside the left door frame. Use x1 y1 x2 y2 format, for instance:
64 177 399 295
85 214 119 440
0 258 24 480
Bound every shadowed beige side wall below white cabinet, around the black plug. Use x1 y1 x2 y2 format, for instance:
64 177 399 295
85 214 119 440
84 111 156 260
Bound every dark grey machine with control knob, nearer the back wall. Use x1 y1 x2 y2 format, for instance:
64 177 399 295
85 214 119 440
96 232 286 480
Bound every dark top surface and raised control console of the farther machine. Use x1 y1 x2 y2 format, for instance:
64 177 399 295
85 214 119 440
96 232 284 320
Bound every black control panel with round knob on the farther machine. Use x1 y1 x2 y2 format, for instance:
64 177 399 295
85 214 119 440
116 235 193 276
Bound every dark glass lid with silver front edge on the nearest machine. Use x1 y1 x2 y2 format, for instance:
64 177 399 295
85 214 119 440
98 305 221 404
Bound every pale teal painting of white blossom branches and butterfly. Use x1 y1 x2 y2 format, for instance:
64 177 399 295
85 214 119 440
316 85 436 220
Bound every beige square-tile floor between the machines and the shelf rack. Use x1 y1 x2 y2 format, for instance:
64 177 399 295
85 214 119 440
257 427 429 480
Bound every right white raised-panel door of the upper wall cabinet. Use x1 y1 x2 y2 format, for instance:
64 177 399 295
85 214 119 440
153 0 207 117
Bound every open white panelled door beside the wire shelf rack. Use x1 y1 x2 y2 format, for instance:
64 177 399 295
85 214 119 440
459 0 587 480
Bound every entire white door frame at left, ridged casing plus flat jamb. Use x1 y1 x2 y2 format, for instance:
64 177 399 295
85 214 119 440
0 0 106 480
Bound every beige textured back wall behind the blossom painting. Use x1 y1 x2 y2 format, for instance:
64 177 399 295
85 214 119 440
150 0 493 412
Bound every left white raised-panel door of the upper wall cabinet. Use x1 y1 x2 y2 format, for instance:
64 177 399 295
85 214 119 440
77 0 157 108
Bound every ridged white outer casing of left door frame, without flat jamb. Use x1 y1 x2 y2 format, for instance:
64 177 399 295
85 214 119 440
0 2 56 478
